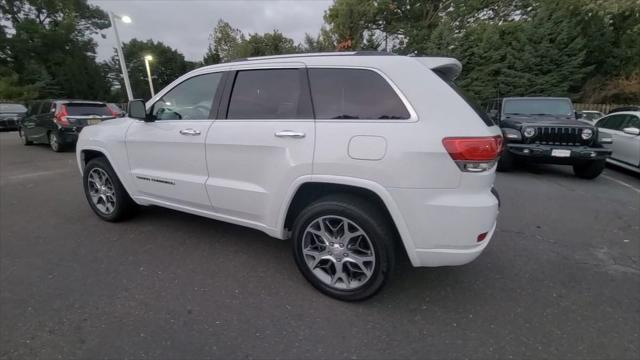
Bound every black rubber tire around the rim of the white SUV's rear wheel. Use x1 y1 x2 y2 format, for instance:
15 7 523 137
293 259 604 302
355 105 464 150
292 194 395 301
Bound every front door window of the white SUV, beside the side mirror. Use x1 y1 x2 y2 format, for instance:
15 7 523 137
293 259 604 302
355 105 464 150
153 73 222 120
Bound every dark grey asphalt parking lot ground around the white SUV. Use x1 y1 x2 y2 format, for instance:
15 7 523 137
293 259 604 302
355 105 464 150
0 132 640 359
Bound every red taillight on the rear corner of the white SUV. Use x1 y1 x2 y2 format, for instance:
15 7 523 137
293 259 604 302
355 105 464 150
442 135 502 161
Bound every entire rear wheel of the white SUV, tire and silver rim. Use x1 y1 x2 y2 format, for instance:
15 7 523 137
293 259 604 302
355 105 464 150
293 195 395 301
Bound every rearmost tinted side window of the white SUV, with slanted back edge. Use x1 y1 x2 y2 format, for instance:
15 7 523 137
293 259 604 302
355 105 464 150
309 69 410 119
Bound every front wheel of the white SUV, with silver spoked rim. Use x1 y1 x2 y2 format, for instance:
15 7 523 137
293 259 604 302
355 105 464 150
83 157 137 222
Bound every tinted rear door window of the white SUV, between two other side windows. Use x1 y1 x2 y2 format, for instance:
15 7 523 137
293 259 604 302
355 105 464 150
227 69 311 119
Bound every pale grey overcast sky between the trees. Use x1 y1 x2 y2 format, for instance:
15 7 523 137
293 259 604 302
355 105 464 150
89 0 333 60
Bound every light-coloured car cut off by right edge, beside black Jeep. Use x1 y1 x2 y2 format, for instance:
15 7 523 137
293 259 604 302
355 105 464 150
596 111 640 171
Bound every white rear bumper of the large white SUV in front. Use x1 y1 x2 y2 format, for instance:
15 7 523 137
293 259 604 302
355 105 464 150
389 188 499 267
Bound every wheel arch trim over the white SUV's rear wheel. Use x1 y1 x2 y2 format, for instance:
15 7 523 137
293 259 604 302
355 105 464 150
278 175 417 263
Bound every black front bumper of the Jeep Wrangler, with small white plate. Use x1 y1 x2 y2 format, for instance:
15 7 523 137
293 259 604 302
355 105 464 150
507 143 611 163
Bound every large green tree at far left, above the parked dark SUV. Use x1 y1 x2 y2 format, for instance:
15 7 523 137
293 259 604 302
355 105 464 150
0 0 109 99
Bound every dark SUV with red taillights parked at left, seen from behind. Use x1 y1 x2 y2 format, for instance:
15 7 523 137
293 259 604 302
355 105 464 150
19 100 116 152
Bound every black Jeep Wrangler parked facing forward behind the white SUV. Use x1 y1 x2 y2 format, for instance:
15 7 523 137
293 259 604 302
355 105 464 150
486 97 612 179
